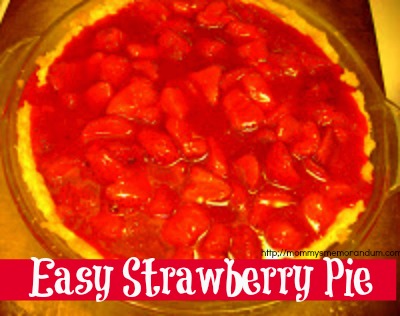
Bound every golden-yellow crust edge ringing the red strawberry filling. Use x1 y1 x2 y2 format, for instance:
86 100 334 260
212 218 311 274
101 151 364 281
18 0 376 258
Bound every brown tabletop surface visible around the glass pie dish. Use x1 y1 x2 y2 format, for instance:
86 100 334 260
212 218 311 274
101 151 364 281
0 0 400 316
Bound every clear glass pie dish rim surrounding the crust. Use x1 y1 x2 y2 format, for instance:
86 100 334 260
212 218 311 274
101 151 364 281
2 1 398 311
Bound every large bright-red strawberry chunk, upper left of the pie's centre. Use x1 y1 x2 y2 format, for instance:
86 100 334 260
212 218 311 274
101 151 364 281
107 77 157 119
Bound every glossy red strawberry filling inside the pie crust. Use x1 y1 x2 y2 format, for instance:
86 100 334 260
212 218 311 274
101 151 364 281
20 0 372 259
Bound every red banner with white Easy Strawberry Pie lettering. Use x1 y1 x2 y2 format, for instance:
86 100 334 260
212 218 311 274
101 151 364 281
0 258 396 302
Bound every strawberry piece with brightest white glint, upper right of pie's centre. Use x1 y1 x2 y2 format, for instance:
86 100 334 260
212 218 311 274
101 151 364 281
242 73 275 110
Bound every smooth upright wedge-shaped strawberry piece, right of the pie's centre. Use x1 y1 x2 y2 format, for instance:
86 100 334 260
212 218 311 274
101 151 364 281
265 142 301 188
